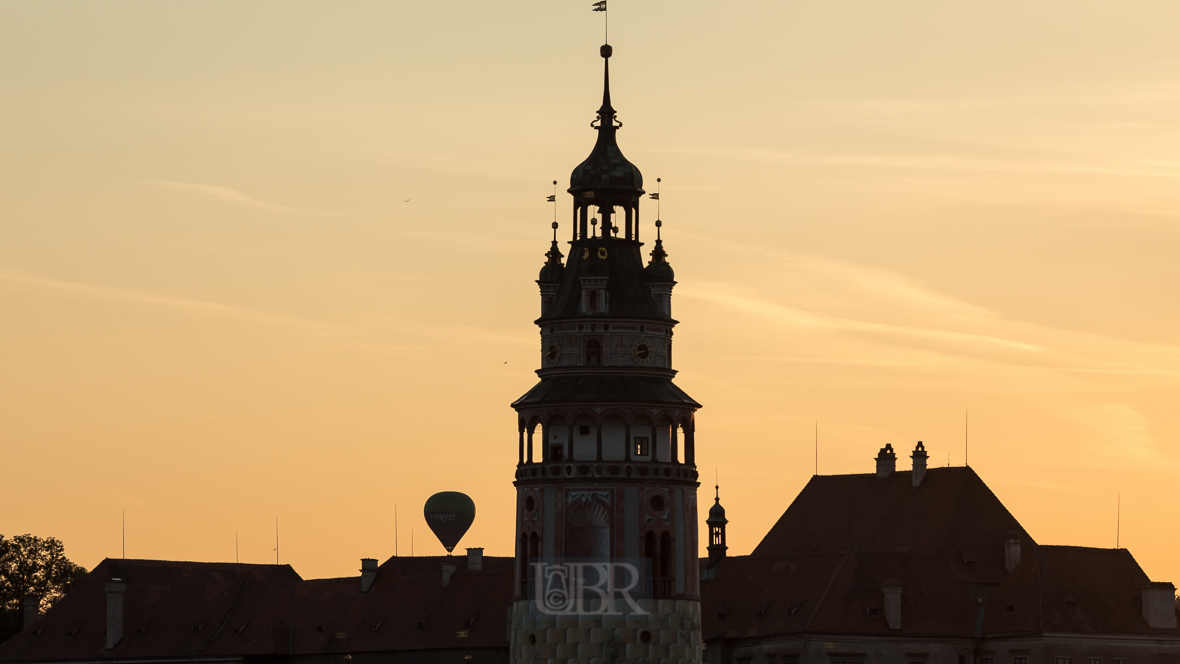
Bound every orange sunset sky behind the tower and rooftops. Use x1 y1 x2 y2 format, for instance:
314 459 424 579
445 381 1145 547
0 0 1180 581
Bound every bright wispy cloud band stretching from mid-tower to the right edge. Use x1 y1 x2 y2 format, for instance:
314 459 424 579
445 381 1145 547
677 241 1180 388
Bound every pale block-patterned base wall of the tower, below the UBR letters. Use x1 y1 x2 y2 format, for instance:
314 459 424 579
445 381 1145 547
509 599 703 664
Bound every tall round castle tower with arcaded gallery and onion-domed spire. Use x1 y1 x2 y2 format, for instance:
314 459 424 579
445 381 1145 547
511 46 702 663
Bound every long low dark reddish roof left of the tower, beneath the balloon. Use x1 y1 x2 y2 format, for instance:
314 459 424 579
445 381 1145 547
0 557 513 662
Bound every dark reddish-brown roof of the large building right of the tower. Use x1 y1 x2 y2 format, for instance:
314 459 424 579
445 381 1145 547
701 468 1180 639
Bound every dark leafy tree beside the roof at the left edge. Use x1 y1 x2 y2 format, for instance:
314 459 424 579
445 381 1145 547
0 534 86 643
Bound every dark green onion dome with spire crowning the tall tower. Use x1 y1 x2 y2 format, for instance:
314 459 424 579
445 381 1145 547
569 45 643 204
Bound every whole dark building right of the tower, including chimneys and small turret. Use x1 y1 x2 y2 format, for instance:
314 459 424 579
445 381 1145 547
701 442 1180 664
